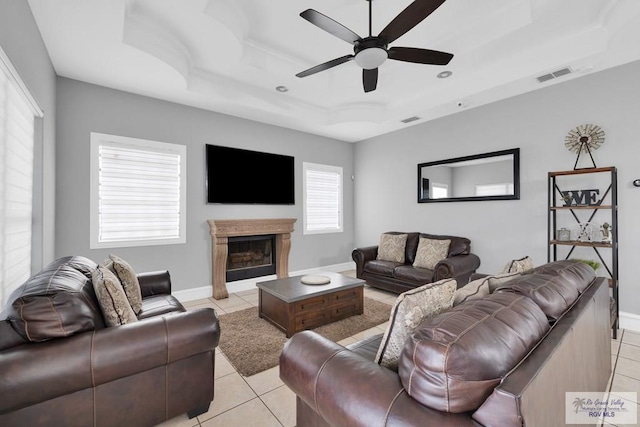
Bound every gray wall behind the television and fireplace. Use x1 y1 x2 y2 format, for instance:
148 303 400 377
56 78 354 290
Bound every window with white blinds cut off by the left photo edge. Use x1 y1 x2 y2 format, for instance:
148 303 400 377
0 48 42 304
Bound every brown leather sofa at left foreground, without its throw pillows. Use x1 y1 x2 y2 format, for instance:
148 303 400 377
0 256 220 426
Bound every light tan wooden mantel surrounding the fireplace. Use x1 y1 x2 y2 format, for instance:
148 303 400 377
207 218 296 299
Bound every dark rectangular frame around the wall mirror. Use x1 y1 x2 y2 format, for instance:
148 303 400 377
418 148 520 203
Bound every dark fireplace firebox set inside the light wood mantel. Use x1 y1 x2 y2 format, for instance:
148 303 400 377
227 235 276 282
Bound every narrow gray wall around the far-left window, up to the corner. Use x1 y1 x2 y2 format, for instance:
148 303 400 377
0 0 56 272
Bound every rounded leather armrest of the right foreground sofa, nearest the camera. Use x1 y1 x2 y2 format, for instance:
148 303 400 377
280 331 471 427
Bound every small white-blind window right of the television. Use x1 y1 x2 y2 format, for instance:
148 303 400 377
302 163 342 234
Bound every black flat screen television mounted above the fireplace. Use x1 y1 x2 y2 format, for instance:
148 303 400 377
206 144 295 205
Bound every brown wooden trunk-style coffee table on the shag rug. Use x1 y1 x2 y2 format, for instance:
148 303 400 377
257 272 365 338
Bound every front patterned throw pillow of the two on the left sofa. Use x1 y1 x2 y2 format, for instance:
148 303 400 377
92 265 138 326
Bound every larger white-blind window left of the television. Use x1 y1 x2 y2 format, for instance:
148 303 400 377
90 133 187 249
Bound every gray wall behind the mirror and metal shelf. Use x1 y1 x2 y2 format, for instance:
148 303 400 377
355 62 640 315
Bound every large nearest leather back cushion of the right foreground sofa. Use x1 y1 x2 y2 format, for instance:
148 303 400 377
398 293 549 413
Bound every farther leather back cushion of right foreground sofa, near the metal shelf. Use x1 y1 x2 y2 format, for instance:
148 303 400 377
495 267 595 321
